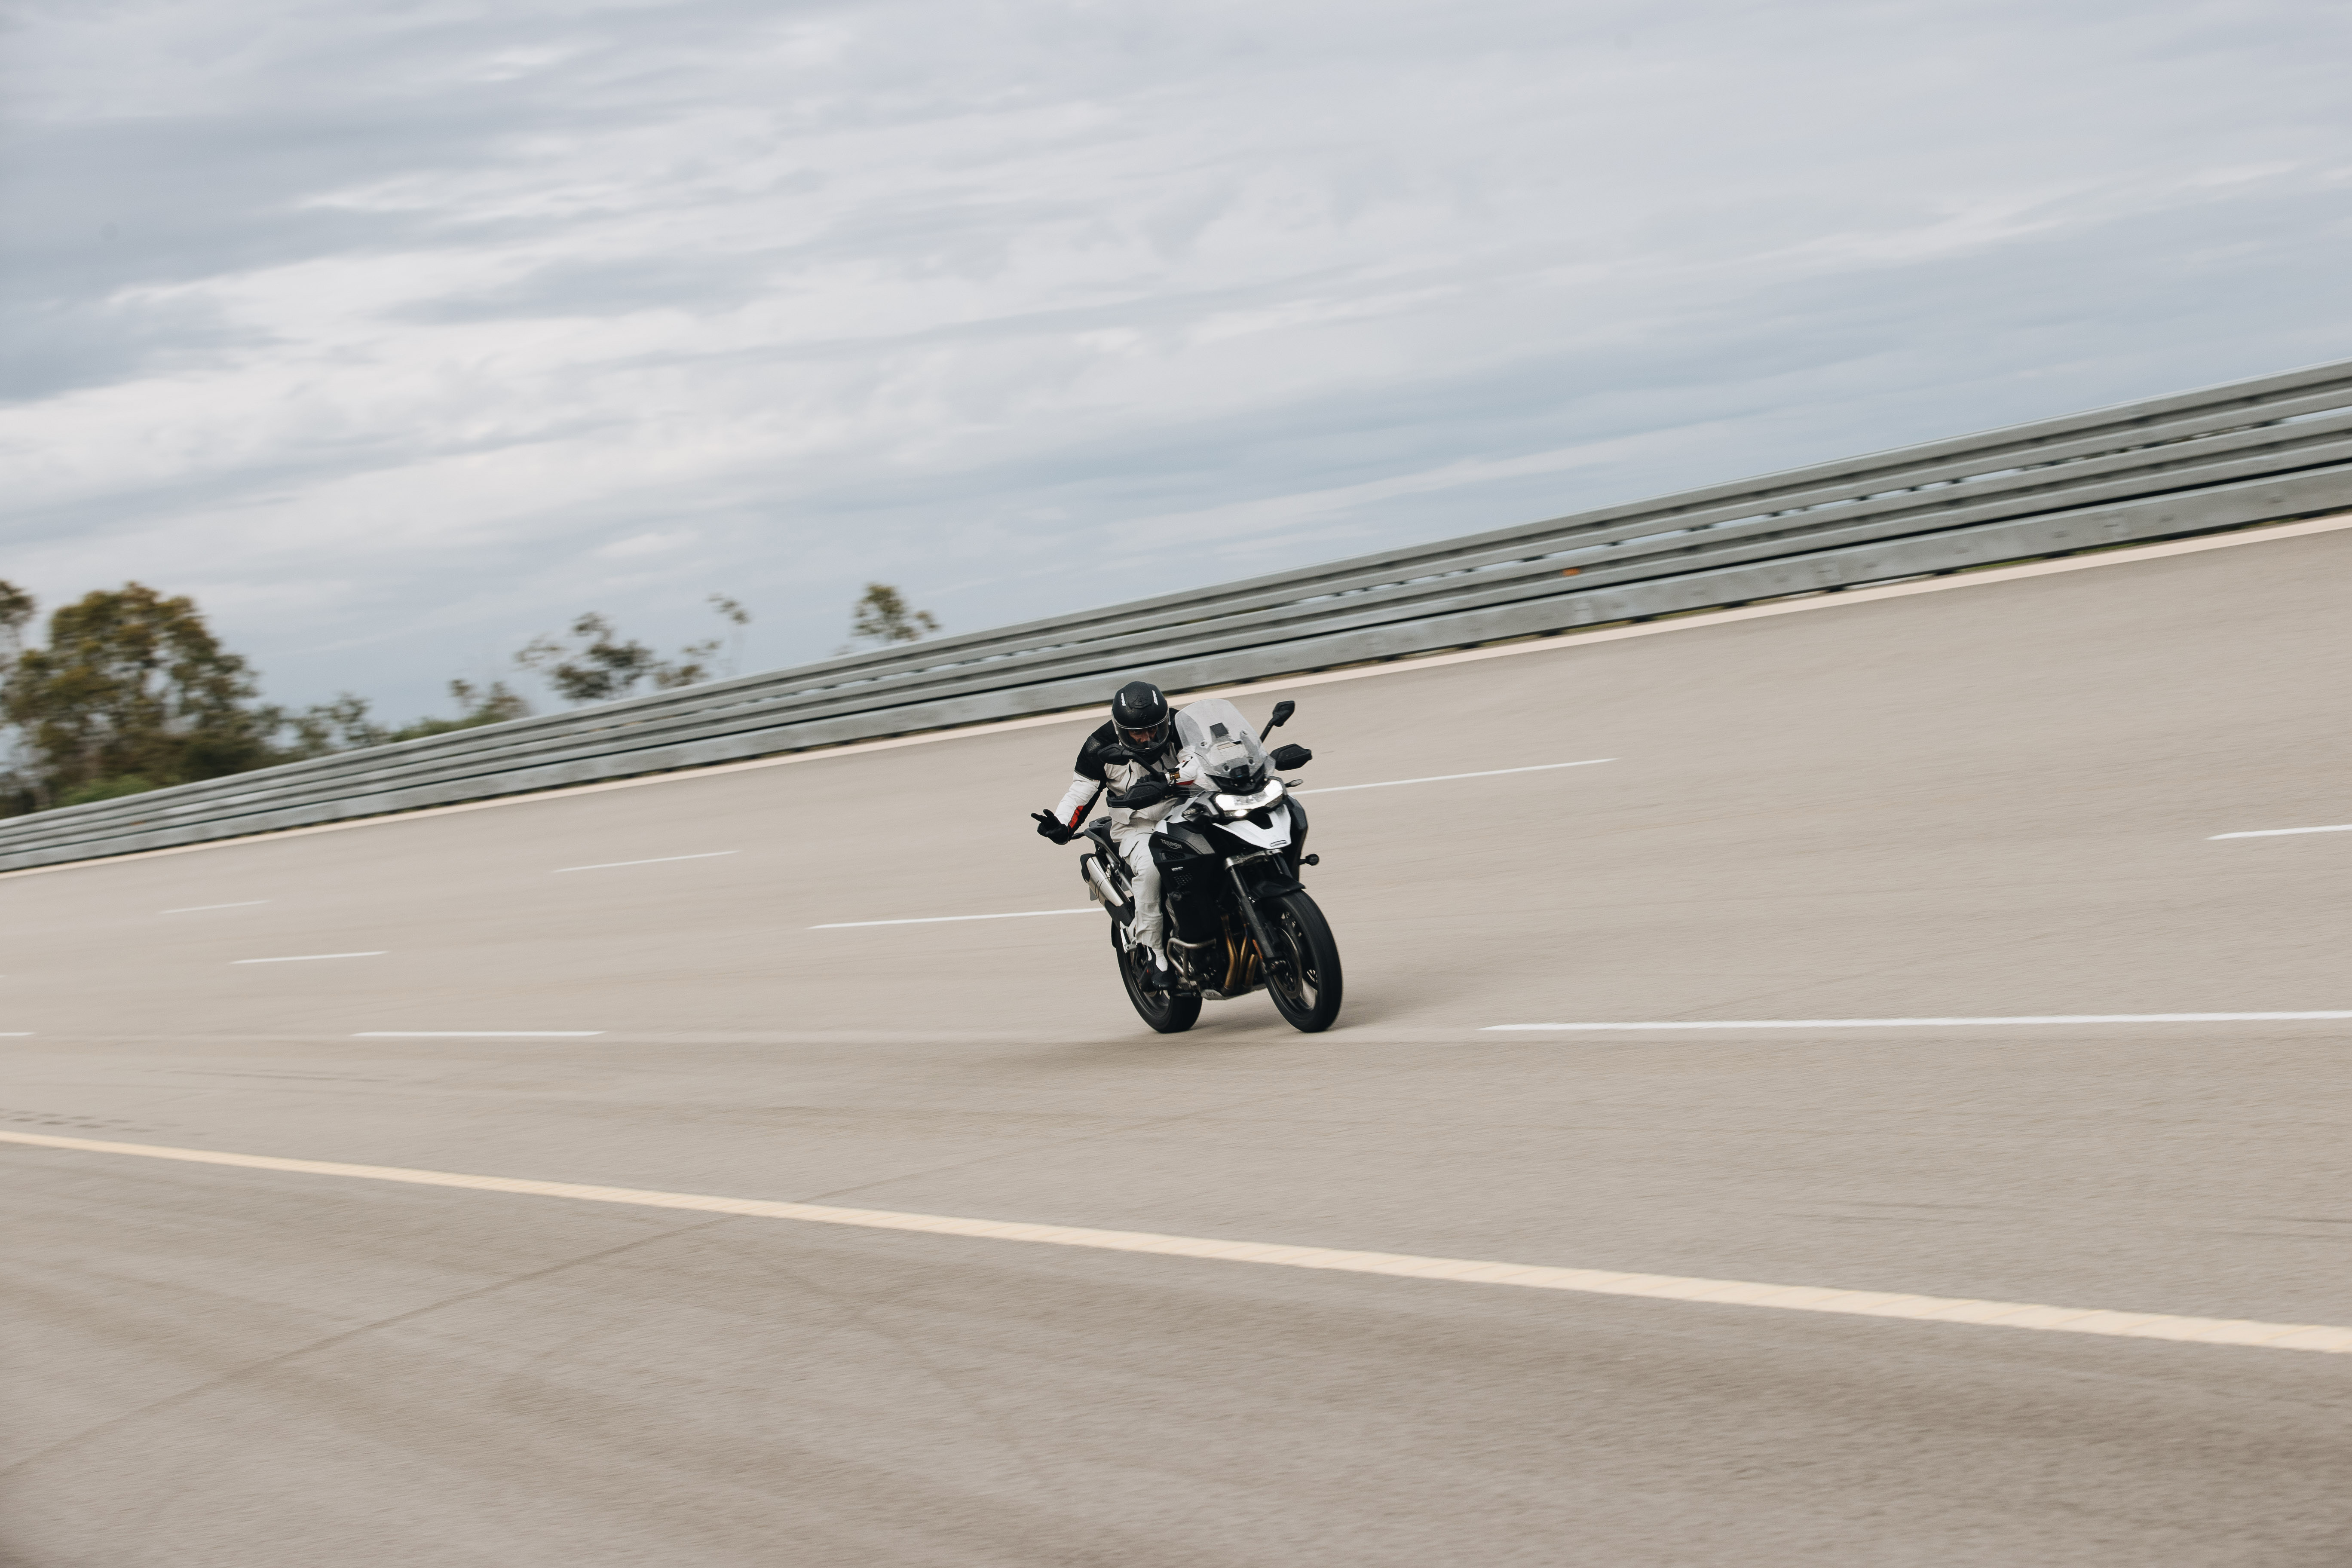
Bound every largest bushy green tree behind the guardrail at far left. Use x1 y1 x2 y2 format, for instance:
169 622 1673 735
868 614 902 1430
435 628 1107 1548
0 583 278 806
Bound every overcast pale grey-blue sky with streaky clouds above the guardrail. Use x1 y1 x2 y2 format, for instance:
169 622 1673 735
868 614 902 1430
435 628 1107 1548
0 0 2352 717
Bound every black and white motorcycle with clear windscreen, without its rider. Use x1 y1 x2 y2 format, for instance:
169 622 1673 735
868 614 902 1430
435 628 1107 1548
1077 698 1341 1034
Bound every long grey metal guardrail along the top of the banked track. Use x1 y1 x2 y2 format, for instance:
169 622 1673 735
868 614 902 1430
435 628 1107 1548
14 360 2352 870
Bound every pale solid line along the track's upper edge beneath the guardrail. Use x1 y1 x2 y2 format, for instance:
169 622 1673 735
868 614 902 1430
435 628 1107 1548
0 512 2352 882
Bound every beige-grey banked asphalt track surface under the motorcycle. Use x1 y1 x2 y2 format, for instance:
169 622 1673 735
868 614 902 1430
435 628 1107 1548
0 531 2352 1568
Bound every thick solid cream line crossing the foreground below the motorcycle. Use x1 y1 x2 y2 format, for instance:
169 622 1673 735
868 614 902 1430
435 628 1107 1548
0 1133 2352 1352
